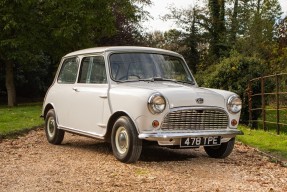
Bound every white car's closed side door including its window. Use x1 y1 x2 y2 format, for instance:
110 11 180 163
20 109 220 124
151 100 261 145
68 55 109 136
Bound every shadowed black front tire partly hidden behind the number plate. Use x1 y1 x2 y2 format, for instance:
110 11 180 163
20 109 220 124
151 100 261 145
204 138 235 158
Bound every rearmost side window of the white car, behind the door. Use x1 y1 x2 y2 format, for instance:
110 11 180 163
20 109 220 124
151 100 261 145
58 57 79 84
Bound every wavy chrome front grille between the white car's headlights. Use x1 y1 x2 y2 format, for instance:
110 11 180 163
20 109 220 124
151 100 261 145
161 109 228 130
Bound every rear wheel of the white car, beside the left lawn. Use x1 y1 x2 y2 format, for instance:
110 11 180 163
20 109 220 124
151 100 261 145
45 109 65 145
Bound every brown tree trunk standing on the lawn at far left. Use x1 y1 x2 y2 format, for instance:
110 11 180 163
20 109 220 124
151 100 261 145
5 61 17 107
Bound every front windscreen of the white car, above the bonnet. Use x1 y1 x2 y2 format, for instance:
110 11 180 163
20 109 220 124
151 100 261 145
110 53 194 84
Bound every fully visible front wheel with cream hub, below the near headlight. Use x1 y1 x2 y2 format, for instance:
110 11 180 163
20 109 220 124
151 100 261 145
111 116 142 163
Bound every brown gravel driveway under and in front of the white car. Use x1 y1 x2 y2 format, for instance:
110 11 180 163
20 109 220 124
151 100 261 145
0 129 287 192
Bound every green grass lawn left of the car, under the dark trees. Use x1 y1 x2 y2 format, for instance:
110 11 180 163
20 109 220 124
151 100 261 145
0 103 44 136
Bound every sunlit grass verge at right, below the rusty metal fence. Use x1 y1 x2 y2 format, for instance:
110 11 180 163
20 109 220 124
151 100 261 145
236 126 287 161
